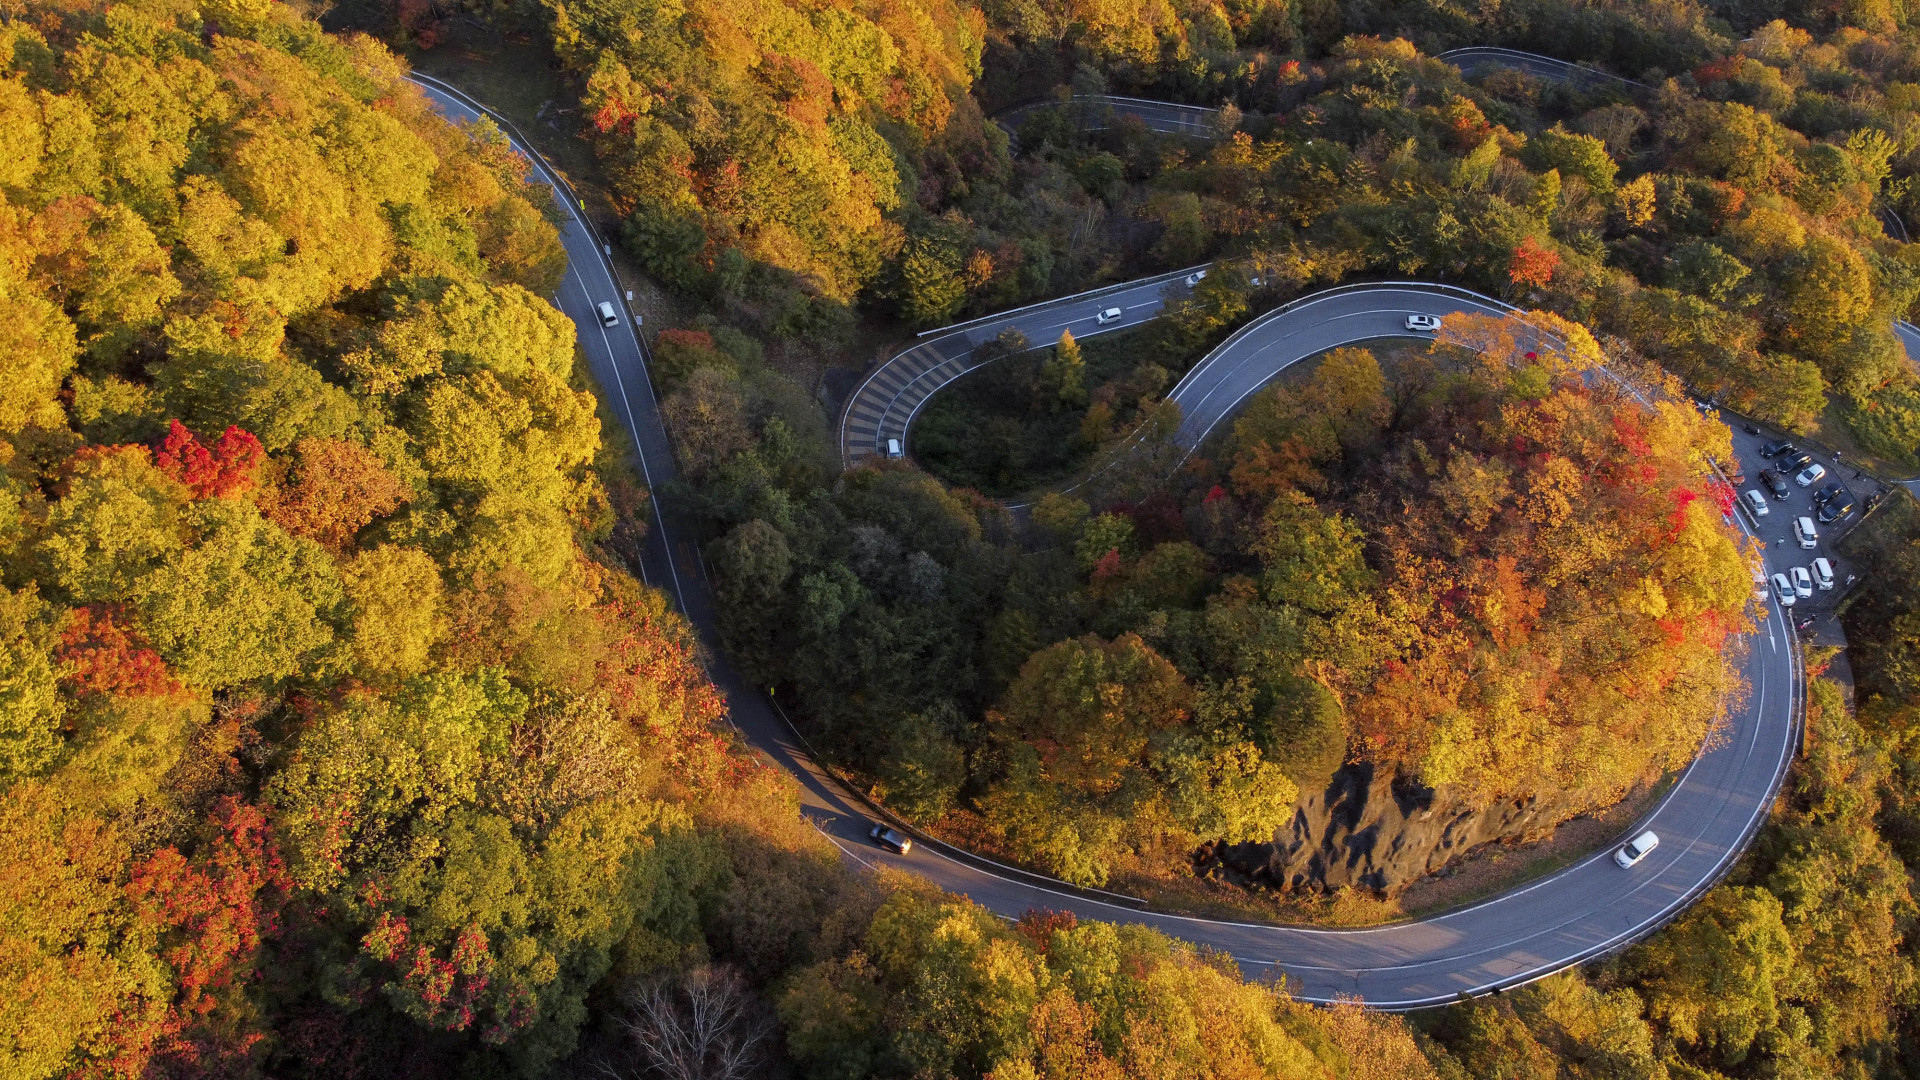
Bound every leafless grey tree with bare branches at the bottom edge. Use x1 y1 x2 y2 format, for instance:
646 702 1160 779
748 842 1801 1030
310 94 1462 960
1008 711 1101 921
605 967 772 1080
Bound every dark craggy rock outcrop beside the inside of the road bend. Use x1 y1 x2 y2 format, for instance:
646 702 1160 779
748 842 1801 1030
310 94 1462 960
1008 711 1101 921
1196 763 1588 894
